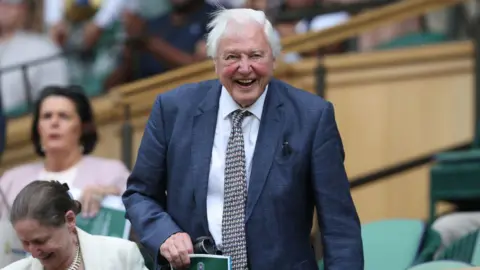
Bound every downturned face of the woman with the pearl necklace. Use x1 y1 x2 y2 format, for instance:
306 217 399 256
13 211 76 269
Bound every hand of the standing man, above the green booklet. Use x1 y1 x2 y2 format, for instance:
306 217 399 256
160 233 193 269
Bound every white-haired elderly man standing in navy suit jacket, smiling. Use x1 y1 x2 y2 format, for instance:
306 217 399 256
123 9 363 270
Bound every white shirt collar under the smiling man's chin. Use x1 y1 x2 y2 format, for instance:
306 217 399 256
219 85 268 120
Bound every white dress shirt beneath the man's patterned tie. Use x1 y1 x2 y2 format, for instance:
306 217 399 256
207 86 268 249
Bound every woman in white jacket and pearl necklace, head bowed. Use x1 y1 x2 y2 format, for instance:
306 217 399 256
3 181 147 270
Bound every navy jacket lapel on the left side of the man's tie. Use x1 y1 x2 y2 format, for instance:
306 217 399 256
191 81 221 233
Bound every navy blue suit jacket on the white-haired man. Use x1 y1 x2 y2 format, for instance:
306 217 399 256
123 79 363 270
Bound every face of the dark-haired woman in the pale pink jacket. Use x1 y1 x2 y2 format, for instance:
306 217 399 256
38 96 82 153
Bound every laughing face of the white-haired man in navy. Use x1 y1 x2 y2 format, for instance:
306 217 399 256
215 22 275 107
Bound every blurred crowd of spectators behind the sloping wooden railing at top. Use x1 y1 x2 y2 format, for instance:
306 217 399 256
0 0 462 117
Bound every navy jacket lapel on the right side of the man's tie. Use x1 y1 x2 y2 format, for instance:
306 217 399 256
245 80 283 223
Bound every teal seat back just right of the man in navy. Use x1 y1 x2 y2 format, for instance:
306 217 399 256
319 219 428 270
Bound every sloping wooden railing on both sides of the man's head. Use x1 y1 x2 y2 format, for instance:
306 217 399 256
109 0 465 106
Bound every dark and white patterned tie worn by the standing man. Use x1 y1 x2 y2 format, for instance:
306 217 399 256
222 110 250 270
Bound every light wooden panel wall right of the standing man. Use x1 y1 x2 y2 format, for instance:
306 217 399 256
325 43 474 222
